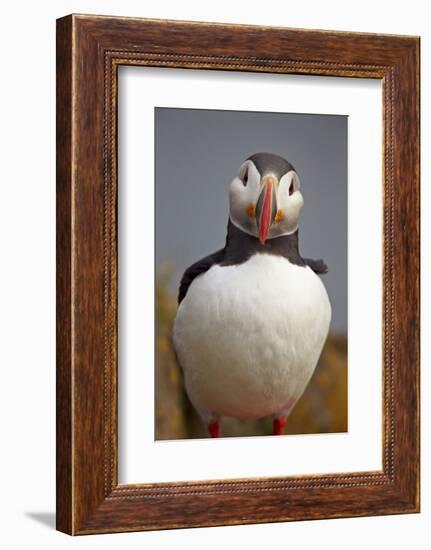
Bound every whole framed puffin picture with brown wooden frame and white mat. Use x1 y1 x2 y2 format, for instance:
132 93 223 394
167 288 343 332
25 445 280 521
57 15 419 535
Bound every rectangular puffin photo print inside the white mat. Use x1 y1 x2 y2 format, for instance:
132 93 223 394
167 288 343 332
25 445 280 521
154 107 348 440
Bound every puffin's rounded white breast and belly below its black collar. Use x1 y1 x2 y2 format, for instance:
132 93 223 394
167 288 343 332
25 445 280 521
174 254 331 418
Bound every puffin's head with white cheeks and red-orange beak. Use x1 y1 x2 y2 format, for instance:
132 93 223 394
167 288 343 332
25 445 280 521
229 153 304 244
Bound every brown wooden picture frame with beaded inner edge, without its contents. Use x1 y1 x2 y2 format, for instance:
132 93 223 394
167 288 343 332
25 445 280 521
57 15 419 534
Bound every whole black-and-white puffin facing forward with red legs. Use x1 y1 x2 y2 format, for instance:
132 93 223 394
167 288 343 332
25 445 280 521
172 153 331 437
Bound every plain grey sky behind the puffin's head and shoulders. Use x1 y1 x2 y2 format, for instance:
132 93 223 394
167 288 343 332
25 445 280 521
155 108 347 333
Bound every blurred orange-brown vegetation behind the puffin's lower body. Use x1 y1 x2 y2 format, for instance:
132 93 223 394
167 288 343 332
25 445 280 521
155 268 347 439
